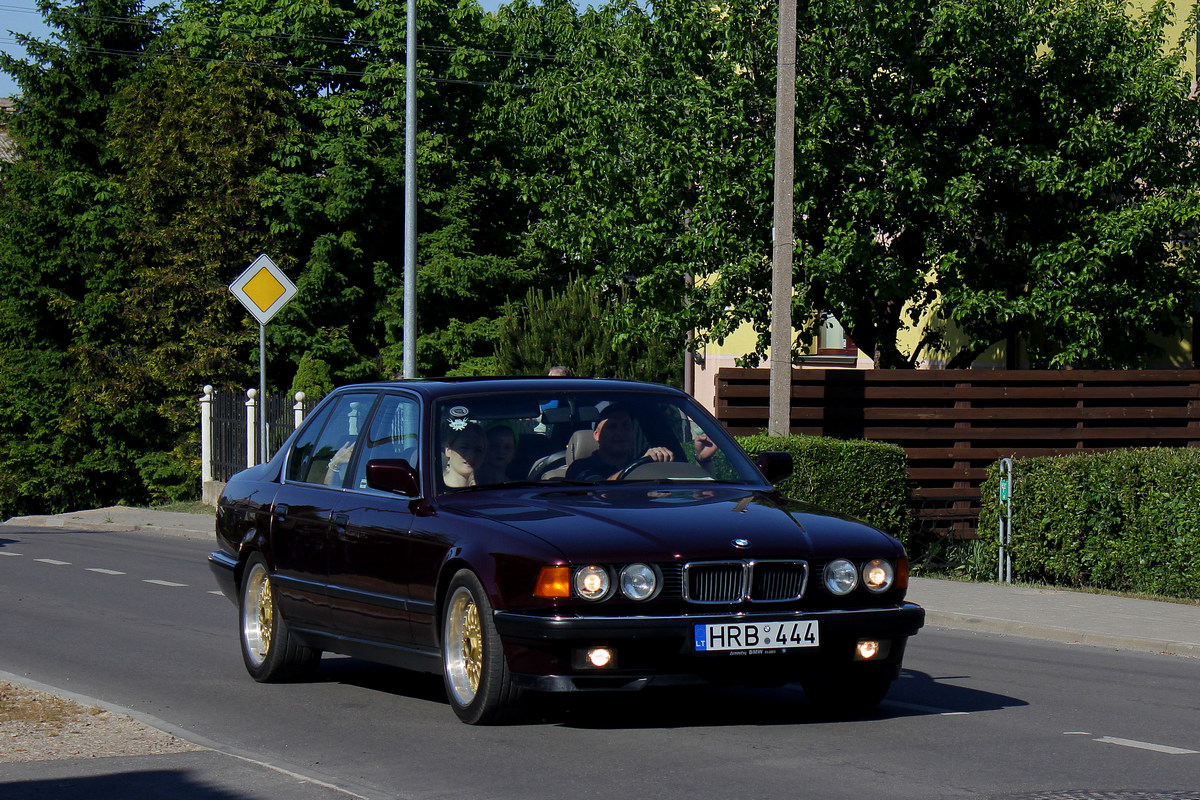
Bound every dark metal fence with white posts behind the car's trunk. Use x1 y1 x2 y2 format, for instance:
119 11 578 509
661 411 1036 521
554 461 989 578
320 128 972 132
199 385 307 503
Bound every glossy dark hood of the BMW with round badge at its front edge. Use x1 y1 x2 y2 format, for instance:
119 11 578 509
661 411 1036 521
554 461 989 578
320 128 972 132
446 486 902 560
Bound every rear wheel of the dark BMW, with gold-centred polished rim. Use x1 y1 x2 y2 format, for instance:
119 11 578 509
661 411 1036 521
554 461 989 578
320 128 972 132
239 553 320 684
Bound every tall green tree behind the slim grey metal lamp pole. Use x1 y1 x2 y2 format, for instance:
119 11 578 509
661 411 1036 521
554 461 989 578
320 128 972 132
175 0 542 383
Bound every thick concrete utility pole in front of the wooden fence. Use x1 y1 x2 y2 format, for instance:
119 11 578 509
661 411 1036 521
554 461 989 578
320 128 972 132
767 0 796 437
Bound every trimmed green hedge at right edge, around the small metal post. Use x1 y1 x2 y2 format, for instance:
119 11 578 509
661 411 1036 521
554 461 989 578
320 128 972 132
979 449 1200 599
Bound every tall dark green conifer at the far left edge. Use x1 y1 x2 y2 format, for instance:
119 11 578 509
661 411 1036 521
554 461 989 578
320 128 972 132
0 0 157 516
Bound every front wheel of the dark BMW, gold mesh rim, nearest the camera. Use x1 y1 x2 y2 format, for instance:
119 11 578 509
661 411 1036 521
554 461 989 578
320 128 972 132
442 570 521 724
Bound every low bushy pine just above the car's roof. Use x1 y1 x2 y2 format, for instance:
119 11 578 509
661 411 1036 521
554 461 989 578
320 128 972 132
497 279 683 385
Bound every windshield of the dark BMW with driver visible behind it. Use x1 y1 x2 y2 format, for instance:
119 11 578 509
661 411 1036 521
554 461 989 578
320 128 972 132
436 391 762 489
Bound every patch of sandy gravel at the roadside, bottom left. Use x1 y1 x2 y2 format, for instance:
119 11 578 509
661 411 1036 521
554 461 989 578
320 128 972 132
0 681 204 764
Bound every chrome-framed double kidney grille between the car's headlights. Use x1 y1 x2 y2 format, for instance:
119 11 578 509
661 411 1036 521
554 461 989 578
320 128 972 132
683 561 809 603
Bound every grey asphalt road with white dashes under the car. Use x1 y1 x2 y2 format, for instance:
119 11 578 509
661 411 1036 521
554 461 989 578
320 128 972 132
0 527 1200 800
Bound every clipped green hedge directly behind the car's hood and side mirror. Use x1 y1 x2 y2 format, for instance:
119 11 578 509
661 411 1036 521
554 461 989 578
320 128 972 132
738 434 911 542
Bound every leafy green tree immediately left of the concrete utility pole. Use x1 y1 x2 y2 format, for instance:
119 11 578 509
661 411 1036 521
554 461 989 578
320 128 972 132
502 0 775 362
